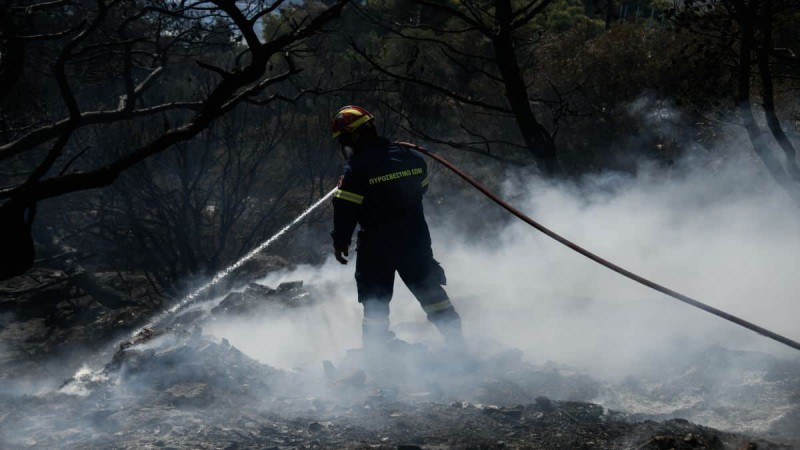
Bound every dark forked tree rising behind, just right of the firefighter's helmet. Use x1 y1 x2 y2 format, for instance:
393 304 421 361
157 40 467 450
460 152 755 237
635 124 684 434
353 0 568 175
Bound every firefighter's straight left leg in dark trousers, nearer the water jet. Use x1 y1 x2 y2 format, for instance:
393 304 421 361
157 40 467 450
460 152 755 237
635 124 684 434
356 241 394 347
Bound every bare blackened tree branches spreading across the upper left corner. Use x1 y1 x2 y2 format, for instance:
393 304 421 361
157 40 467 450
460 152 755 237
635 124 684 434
0 0 348 280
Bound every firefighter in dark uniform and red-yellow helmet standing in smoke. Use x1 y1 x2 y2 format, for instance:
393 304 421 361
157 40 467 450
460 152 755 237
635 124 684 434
331 106 463 349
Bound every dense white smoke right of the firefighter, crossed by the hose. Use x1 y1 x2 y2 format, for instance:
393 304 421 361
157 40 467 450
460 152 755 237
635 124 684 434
444 156 800 376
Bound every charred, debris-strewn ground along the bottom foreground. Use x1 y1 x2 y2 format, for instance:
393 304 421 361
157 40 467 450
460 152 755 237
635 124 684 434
0 330 790 449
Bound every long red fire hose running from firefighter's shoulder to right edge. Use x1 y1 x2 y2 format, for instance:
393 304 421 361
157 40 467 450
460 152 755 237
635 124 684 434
397 142 800 350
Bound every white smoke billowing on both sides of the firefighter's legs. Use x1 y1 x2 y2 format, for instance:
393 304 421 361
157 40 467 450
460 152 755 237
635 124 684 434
208 129 800 378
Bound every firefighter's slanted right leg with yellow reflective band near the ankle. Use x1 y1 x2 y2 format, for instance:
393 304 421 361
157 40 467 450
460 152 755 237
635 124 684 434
399 253 463 346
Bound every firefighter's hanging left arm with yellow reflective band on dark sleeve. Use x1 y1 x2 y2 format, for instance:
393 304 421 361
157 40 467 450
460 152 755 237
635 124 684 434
331 166 364 264
